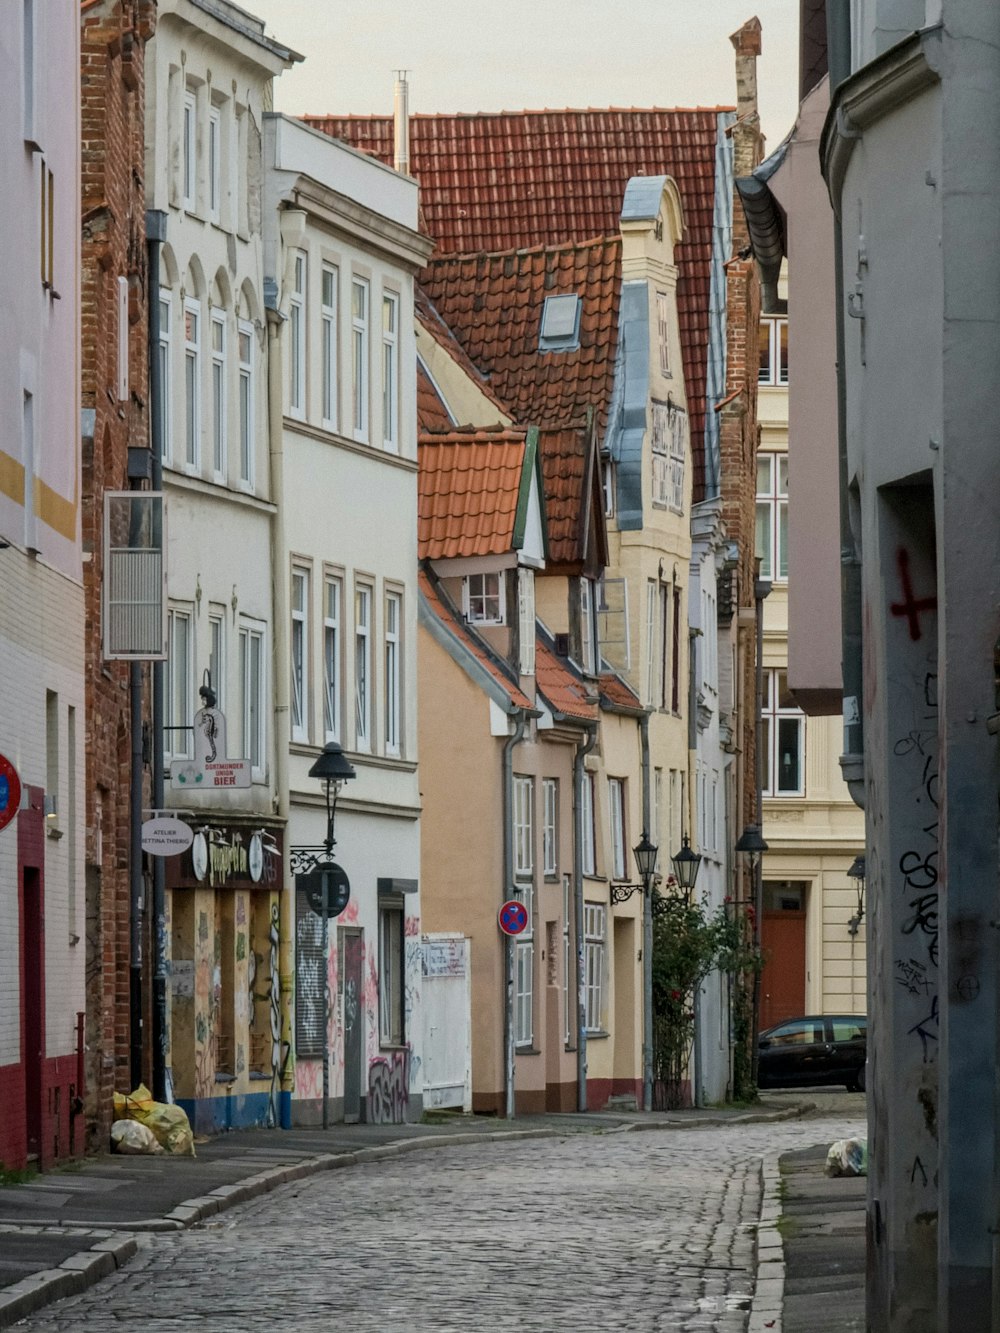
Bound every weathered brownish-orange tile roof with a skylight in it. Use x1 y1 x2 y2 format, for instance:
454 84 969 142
423 236 621 429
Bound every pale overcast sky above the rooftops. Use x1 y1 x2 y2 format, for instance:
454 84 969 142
252 0 799 151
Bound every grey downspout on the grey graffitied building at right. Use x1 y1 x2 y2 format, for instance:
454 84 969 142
827 0 864 809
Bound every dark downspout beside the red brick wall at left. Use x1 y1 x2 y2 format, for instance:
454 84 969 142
145 208 167 1101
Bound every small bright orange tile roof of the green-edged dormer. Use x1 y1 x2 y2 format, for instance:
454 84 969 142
417 428 527 560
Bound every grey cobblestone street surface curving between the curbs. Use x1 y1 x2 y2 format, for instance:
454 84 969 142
17 1116 861 1333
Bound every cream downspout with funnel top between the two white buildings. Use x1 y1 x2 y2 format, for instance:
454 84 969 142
264 209 305 1129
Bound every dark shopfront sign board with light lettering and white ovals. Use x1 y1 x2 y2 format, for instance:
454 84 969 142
164 820 284 890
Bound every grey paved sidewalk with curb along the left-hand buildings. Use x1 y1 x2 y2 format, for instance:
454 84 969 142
0 1097 816 1329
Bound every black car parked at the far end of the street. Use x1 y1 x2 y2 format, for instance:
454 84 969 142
757 1013 868 1092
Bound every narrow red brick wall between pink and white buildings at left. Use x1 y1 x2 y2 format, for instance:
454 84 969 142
80 0 156 1145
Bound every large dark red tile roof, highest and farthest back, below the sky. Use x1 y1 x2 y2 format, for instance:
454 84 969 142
305 107 732 496
